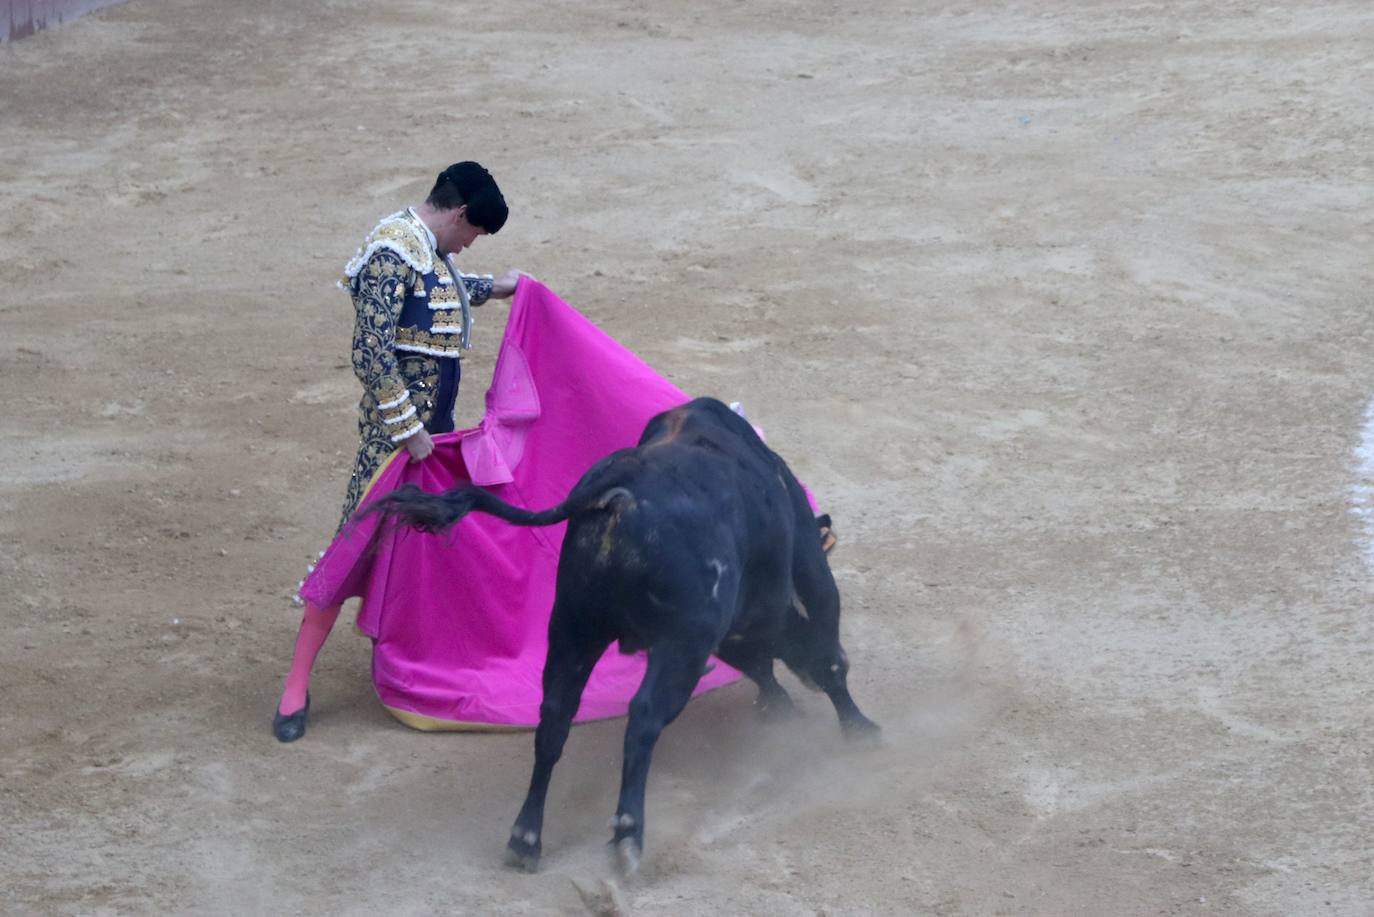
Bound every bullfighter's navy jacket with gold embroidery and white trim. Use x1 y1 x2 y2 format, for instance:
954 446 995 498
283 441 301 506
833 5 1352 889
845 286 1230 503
339 209 492 443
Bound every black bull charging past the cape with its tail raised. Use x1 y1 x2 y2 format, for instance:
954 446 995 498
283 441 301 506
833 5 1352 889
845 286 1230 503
371 399 878 872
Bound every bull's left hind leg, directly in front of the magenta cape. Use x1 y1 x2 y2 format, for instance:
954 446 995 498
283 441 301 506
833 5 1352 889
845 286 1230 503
506 605 610 872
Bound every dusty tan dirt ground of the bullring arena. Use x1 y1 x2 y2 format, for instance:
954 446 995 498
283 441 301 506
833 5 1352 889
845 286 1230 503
0 0 1374 917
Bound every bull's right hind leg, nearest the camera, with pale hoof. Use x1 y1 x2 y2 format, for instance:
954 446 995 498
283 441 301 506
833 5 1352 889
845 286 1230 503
610 637 710 876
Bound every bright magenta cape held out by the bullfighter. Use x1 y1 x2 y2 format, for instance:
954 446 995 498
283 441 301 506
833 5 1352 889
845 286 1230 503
301 279 739 729
